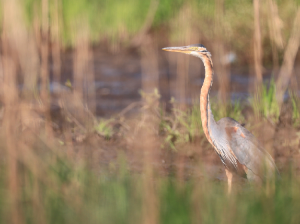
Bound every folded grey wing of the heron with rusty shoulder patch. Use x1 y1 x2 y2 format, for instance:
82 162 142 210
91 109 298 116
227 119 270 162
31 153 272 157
218 118 277 179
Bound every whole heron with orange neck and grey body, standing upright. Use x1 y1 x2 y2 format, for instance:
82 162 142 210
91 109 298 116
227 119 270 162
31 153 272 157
163 44 276 192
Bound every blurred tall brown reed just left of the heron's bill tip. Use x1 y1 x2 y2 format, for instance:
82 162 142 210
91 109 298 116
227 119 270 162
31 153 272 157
136 41 160 224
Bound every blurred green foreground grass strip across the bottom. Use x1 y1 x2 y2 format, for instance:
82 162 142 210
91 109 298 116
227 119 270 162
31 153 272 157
0 150 300 224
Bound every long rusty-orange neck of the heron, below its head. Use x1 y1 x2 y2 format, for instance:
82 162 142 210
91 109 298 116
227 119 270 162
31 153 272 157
200 56 217 144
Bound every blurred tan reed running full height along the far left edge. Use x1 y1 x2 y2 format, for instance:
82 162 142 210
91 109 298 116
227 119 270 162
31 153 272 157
1 1 22 224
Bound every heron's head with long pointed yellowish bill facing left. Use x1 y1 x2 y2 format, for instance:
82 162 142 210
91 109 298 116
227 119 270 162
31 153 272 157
163 44 211 59
